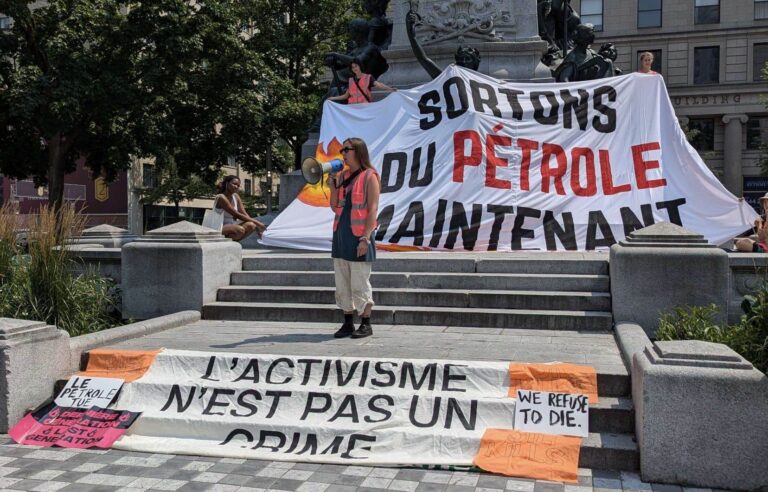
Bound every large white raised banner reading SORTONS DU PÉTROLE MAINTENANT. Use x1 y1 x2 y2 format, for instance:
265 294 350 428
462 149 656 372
263 66 757 251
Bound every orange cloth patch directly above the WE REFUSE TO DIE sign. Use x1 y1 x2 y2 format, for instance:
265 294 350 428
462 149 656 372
509 362 597 405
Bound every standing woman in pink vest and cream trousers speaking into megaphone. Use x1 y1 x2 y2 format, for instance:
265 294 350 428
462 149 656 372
328 138 380 338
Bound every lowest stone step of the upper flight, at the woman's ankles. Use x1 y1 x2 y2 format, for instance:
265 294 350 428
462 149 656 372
202 302 613 331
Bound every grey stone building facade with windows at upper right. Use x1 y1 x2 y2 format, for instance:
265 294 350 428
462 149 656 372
571 0 768 208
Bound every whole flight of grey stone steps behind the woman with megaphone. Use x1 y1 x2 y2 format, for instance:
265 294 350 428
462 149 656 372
203 254 613 331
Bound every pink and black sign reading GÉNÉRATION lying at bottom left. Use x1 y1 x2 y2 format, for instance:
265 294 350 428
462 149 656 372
8 403 141 448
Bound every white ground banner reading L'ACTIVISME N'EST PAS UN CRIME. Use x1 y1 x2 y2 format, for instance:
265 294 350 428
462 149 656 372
114 350 516 466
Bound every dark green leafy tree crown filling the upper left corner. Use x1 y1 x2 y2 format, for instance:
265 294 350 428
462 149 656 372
0 0 286 207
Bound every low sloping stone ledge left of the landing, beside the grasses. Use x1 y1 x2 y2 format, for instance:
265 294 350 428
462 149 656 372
69 311 200 373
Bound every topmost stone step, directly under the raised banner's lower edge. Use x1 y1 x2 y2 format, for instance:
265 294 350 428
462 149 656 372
243 253 608 275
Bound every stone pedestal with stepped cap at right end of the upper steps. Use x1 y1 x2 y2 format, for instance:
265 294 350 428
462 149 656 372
610 222 730 338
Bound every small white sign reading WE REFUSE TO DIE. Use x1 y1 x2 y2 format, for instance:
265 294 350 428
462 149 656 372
515 390 589 437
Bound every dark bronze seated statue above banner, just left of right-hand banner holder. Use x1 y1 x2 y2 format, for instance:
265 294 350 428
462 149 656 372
554 24 616 82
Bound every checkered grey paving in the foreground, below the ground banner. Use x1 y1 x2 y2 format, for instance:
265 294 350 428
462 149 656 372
0 435 709 492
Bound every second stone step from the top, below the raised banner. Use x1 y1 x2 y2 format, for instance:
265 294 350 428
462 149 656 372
230 270 610 292
